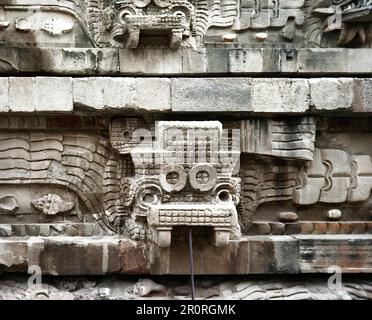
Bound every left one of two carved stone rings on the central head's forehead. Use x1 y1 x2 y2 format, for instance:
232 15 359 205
160 165 187 192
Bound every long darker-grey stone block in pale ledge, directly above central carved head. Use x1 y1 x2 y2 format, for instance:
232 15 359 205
171 78 252 112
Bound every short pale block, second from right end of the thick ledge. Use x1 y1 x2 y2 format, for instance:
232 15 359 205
309 78 353 110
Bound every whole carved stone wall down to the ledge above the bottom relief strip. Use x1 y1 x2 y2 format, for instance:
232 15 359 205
0 0 372 275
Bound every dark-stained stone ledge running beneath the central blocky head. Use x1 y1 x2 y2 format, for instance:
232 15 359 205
0 235 372 275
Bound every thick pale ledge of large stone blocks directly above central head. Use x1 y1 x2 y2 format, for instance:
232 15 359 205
0 77 372 114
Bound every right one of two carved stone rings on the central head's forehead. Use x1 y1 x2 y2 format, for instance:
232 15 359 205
189 164 217 191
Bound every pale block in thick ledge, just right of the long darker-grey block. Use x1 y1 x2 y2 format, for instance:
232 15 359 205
252 78 309 113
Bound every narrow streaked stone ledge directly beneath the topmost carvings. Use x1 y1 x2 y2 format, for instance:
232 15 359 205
0 47 372 76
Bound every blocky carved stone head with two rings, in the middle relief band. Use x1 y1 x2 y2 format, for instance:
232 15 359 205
111 120 240 247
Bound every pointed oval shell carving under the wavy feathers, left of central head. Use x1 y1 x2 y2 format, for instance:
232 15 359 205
32 193 75 215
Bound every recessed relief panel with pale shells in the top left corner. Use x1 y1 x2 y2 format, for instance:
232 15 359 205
0 0 94 47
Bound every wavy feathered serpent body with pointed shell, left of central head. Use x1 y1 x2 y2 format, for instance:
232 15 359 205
0 118 112 234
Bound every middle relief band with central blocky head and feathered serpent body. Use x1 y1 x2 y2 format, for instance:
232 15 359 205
0 117 372 247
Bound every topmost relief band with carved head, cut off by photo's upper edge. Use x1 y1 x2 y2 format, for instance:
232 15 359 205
0 0 372 49
